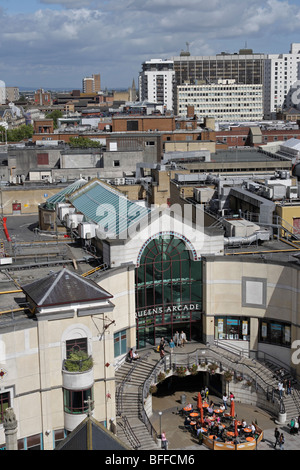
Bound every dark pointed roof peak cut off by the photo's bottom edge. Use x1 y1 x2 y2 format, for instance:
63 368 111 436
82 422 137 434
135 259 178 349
55 417 130 451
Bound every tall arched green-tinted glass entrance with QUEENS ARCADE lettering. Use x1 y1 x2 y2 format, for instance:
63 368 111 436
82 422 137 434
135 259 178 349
136 235 202 348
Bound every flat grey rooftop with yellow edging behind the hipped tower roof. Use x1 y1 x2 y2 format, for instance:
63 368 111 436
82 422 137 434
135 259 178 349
0 215 100 330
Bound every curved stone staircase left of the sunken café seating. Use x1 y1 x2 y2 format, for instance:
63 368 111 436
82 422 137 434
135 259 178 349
116 352 159 450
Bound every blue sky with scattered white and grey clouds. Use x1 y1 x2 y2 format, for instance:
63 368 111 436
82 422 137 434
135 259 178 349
0 0 300 89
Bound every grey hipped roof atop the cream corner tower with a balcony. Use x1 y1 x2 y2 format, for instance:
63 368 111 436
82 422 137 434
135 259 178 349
22 268 112 307
